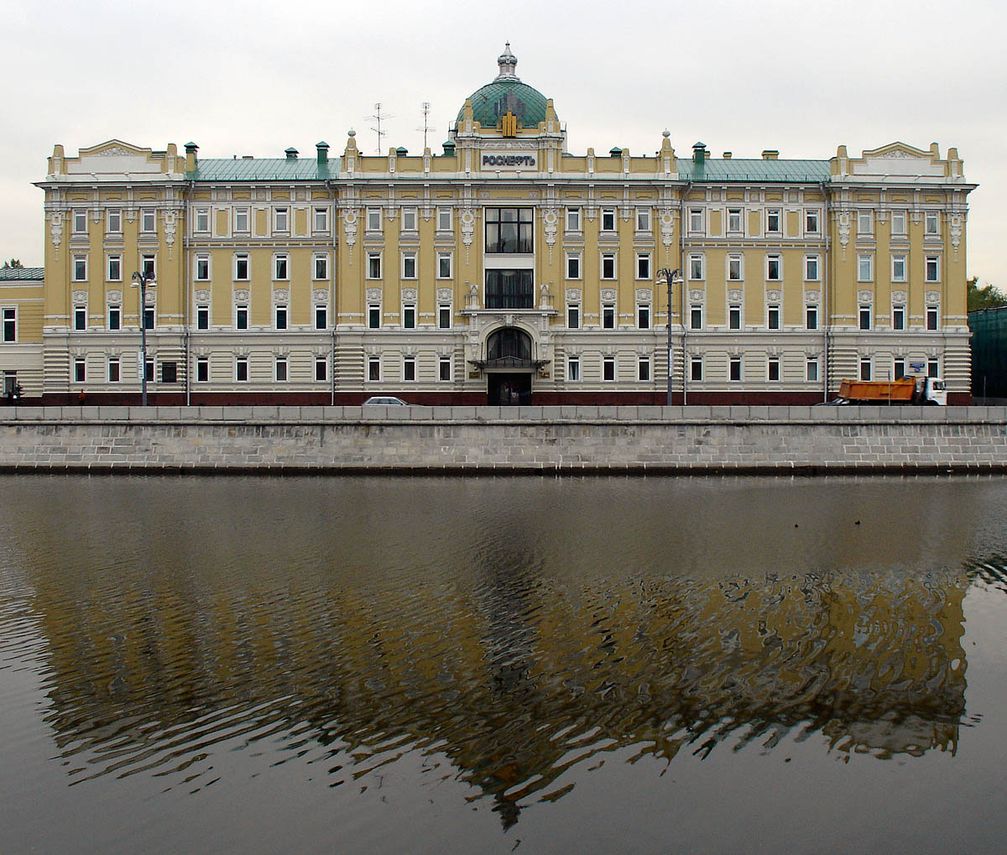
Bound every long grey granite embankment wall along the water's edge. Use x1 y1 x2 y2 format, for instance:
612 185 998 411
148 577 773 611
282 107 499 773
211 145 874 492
0 407 1007 474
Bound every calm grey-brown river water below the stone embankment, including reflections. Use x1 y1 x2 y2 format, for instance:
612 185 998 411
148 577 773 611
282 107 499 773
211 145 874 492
0 476 1007 853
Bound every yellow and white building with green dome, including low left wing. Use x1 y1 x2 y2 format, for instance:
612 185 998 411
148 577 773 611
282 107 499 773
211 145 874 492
0 45 975 404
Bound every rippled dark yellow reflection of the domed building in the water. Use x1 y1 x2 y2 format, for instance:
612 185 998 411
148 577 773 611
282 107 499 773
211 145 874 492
36 559 968 824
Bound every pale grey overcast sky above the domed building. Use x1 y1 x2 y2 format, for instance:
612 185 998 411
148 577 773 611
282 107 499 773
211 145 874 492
0 0 1007 288
